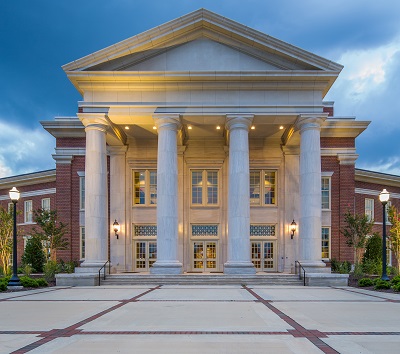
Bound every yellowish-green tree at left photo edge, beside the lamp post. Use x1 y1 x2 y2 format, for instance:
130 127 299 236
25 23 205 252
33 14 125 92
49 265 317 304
0 207 14 274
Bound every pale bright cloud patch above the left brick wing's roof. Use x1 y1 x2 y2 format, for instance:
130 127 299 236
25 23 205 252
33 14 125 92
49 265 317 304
0 118 55 178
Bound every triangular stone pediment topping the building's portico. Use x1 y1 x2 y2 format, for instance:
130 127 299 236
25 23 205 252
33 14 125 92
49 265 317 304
63 9 342 73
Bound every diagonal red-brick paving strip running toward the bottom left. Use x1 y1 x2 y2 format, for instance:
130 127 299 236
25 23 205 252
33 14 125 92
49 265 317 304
10 285 161 354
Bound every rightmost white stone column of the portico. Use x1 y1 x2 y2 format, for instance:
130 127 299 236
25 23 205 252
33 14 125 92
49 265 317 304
296 115 328 272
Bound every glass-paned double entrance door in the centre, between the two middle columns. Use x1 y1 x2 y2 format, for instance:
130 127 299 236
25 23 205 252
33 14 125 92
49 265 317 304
192 241 217 272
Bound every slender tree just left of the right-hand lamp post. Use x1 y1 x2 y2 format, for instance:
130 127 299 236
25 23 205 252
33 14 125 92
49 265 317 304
340 211 374 264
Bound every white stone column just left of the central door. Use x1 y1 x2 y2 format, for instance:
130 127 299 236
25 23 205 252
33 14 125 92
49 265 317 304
150 114 182 274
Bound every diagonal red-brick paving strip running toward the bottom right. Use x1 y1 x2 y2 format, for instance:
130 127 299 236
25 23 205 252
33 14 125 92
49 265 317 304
243 285 339 354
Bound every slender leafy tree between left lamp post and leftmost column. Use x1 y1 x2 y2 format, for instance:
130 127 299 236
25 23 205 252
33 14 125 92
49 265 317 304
33 209 69 261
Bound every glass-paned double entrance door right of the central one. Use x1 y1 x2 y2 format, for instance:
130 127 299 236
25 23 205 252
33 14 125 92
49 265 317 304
251 241 276 272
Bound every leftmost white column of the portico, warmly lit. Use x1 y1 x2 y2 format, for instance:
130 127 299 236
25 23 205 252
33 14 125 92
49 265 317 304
78 113 109 272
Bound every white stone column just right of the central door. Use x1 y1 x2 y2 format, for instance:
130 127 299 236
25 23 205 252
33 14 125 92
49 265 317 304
224 115 256 274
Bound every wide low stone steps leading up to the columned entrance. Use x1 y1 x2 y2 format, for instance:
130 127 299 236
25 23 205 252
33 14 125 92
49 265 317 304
101 273 303 286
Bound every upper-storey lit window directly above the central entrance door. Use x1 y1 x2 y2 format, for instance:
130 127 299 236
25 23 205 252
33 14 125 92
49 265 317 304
192 170 218 206
